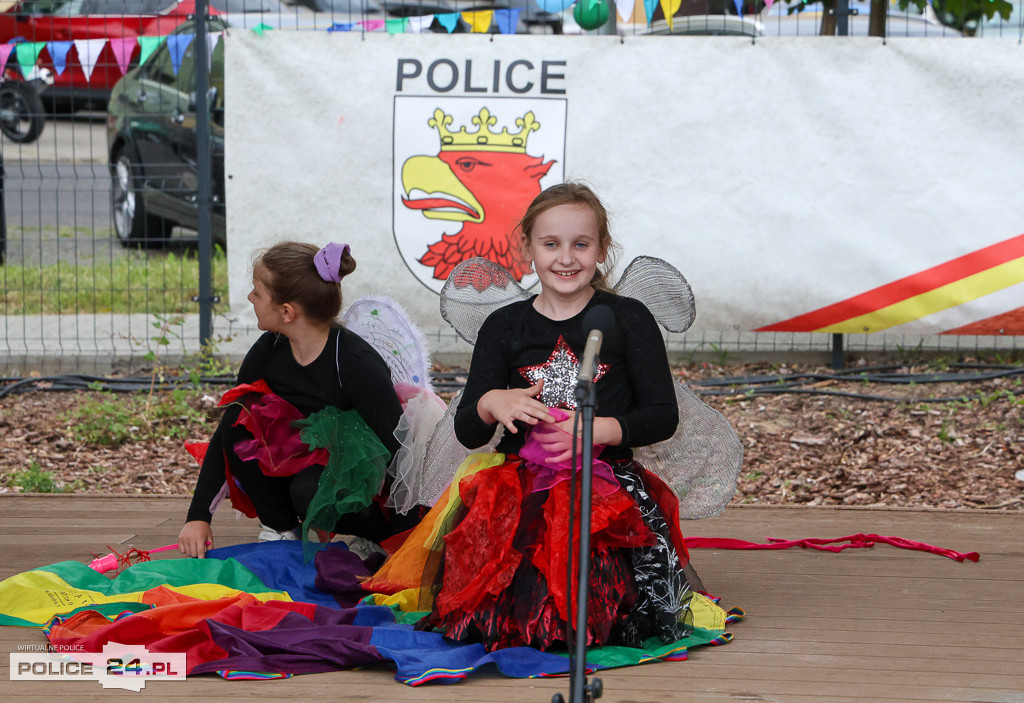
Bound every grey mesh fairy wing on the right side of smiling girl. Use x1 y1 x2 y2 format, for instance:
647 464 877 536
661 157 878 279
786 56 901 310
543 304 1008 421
615 256 743 513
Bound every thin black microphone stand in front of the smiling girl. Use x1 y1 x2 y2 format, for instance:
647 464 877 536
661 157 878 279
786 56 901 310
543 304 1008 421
551 370 604 703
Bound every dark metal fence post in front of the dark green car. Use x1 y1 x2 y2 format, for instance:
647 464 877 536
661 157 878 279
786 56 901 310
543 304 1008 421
194 0 214 347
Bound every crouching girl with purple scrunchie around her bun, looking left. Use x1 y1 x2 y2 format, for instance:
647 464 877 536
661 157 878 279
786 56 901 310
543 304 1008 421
178 241 406 558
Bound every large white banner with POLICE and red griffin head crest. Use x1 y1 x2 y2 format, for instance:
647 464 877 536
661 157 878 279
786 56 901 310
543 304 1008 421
225 32 1024 345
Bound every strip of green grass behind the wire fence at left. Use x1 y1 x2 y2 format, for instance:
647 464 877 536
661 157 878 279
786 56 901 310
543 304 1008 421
0 251 227 315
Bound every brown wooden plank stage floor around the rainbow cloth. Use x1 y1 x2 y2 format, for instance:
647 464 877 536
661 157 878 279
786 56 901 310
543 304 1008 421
0 495 1024 703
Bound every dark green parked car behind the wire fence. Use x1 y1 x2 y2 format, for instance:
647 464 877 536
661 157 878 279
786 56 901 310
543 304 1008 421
106 19 226 247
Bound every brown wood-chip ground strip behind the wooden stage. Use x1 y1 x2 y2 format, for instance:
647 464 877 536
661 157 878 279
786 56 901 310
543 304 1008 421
0 359 1024 511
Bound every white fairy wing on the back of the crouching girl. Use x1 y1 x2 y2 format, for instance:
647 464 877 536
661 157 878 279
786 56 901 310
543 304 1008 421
342 296 433 391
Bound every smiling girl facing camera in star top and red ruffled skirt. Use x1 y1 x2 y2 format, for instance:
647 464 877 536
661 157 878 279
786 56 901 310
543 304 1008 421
365 183 701 650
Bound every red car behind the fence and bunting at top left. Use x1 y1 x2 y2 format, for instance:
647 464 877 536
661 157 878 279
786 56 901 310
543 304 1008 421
0 0 209 107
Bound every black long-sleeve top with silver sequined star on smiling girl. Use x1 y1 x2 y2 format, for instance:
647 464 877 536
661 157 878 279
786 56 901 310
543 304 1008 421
455 291 679 462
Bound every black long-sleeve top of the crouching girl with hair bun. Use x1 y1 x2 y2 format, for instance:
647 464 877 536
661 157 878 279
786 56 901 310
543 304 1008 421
187 327 401 522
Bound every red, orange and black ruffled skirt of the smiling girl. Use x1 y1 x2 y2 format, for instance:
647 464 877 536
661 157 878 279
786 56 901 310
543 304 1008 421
365 454 691 650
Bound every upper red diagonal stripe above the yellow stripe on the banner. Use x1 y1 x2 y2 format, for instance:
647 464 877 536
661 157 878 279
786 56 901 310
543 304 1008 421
754 234 1024 332
